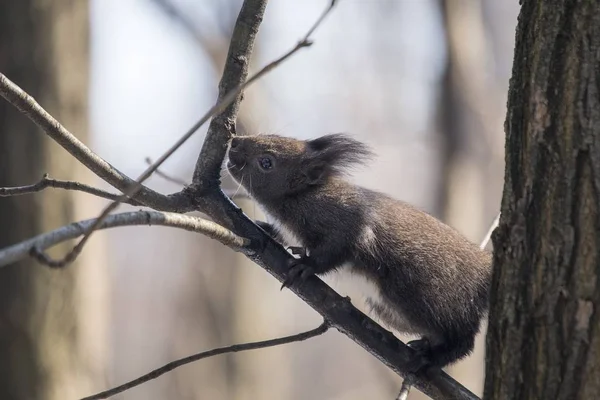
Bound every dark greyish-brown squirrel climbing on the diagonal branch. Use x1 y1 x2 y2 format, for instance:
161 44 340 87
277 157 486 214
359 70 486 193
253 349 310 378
227 133 492 373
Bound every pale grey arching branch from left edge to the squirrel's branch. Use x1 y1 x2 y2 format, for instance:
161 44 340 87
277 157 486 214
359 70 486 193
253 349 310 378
0 211 250 267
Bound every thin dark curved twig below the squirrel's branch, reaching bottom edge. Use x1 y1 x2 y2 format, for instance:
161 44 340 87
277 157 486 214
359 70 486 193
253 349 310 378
81 321 329 400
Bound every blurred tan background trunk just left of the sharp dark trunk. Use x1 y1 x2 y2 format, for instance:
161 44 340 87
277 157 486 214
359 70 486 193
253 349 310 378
432 0 502 399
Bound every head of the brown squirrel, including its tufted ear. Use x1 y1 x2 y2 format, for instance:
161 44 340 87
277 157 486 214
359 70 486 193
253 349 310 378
227 133 373 199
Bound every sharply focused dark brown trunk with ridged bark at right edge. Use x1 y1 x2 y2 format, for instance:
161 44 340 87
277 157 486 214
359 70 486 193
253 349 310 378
485 0 600 399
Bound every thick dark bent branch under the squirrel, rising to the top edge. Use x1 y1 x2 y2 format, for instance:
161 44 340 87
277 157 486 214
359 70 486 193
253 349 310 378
168 0 478 400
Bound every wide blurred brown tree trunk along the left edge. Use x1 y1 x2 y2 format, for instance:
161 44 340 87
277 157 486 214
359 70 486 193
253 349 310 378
0 0 106 400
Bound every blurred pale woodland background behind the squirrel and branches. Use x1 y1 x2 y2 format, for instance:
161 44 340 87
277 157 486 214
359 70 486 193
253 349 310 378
0 0 518 400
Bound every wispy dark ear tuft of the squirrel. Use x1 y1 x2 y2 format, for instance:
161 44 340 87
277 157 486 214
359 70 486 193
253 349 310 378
306 133 373 173
